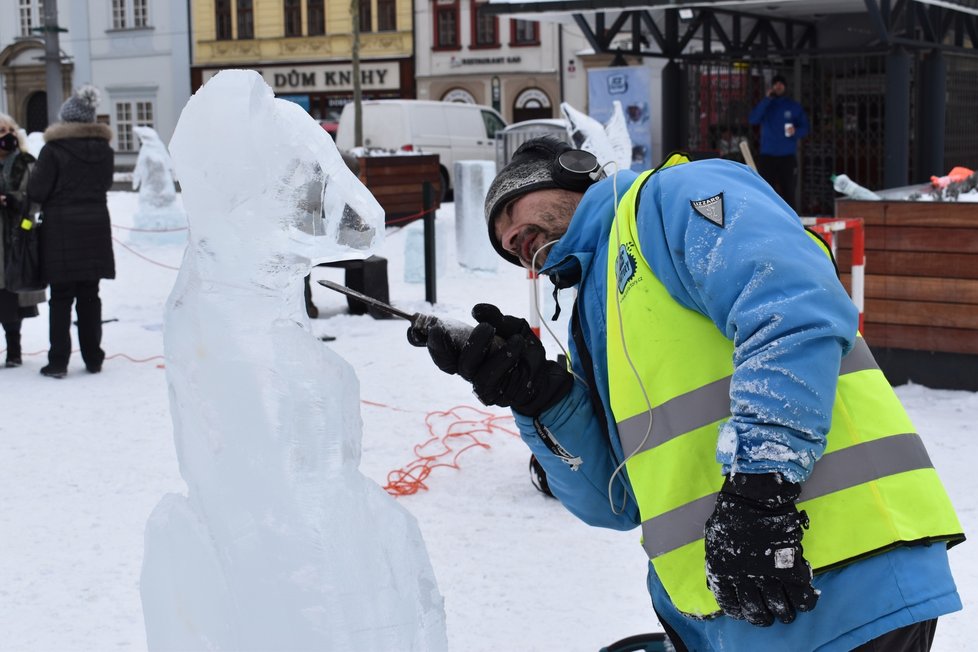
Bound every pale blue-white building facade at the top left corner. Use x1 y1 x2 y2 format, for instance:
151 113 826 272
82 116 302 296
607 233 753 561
0 0 190 167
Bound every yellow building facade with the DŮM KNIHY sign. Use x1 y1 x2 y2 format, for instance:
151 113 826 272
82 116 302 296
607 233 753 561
191 0 415 122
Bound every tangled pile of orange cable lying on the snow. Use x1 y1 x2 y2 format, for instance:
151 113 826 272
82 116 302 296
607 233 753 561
384 405 519 497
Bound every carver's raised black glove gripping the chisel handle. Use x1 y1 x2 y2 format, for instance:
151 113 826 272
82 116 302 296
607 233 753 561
408 303 574 417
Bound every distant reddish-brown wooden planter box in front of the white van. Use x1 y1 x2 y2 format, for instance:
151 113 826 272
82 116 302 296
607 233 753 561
357 154 441 226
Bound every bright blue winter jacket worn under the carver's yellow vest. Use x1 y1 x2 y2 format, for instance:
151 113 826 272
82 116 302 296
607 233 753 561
515 159 961 651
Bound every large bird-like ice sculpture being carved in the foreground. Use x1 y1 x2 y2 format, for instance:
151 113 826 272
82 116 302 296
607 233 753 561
140 70 447 652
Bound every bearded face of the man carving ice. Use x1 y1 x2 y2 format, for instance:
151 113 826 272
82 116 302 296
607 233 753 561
494 189 582 271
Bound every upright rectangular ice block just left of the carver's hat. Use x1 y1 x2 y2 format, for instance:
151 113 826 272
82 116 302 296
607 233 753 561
455 161 499 272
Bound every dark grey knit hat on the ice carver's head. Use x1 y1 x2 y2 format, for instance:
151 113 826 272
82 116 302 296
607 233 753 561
486 136 573 267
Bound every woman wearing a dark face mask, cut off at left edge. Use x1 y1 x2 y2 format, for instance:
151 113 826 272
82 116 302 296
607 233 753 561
0 113 45 367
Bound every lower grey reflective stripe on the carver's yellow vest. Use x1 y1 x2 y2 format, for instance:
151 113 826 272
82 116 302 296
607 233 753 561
642 433 933 559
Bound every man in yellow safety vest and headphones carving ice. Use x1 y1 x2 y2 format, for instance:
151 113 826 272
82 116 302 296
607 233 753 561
408 138 964 652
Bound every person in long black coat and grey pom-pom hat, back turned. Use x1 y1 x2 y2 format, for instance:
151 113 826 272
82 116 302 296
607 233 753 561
27 86 115 378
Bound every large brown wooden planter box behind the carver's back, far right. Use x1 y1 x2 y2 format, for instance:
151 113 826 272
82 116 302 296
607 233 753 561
835 200 978 388
